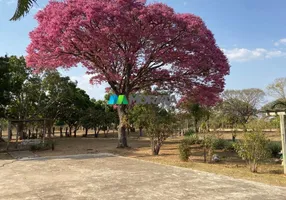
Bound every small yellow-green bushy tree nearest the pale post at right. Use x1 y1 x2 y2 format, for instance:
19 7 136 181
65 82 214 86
234 131 270 172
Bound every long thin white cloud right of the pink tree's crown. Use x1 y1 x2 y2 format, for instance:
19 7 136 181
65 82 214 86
222 48 286 62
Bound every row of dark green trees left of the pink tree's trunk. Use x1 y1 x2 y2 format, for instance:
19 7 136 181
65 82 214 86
0 56 118 138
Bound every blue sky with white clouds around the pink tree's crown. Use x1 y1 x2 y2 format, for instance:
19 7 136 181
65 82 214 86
0 0 286 99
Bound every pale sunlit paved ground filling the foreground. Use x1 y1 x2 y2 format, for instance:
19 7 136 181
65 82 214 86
0 154 286 200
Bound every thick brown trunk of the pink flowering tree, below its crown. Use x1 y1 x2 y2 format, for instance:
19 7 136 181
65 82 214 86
117 105 128 148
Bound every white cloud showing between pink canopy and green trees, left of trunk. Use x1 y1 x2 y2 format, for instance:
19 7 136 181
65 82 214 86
70 74 108 100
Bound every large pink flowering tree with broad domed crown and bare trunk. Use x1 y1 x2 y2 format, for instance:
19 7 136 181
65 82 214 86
26 0 229 147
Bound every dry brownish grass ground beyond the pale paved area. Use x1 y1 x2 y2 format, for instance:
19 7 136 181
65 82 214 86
0 130 286 186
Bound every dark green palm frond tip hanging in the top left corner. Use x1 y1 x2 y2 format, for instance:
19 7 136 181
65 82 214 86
10 0 37 21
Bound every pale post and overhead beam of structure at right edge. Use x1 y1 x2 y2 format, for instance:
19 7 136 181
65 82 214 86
263 109 286 174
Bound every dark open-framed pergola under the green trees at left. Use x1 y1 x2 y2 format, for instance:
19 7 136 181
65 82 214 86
7 119 50 151
